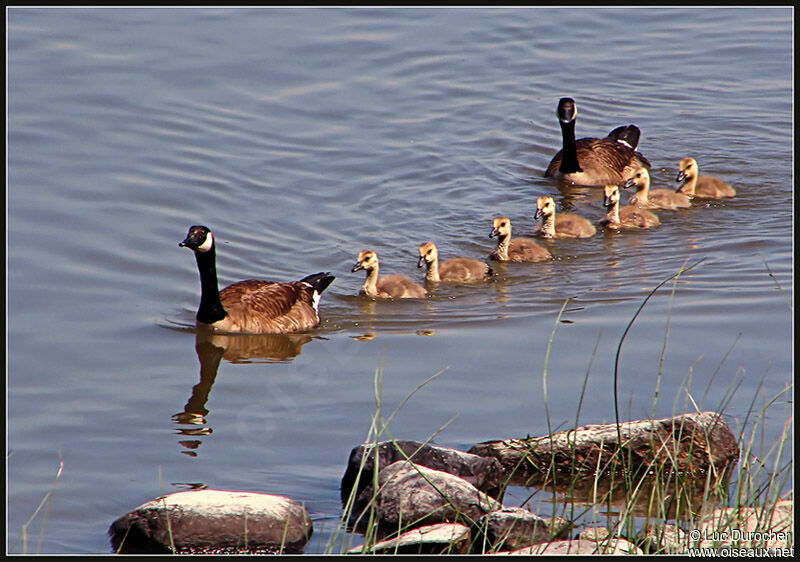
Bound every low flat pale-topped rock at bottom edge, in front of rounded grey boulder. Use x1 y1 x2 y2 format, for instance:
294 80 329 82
348 523 470 554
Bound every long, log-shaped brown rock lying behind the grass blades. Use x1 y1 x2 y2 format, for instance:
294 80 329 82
469 412 739 485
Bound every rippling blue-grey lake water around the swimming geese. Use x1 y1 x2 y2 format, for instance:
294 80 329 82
6 8 793 554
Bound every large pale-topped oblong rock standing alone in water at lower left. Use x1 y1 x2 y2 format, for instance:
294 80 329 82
109 489 313 553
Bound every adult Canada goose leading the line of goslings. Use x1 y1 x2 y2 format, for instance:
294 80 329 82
178 226 334 334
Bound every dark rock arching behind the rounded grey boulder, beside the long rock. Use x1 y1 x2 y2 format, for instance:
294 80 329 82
342 441 503 504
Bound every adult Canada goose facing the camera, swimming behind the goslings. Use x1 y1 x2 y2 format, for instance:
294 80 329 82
544 98 650 185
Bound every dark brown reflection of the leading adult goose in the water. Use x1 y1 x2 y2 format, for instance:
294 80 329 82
172 328 312 456
